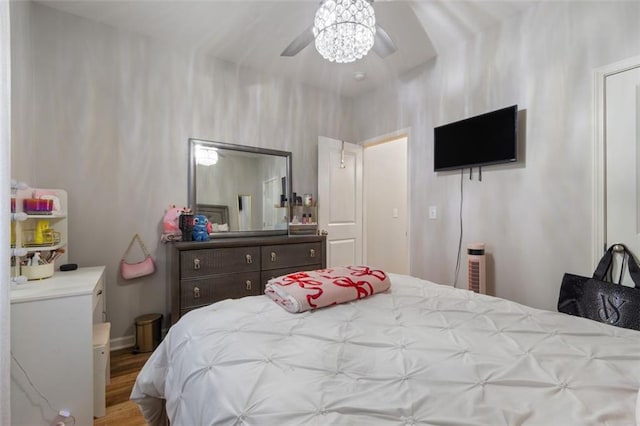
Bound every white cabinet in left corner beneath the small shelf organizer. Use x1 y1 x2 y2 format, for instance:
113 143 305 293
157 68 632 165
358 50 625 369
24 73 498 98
10 266 105 426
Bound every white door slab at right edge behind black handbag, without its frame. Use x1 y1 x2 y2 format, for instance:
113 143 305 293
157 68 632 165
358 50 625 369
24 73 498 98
605 65 640 285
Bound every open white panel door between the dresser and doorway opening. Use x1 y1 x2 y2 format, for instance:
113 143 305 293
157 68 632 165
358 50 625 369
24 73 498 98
318 136 362 268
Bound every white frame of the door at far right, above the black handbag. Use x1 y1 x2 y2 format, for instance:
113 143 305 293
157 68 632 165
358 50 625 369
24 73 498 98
591 56 640 265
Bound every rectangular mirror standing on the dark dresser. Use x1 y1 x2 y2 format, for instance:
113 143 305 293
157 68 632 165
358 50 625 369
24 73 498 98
188 139 291 238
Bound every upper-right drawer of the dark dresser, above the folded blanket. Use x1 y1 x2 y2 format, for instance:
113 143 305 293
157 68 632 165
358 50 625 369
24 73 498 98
262 243 322 270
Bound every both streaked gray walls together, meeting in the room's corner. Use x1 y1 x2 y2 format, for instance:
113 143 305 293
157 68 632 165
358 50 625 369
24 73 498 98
11 2 640 338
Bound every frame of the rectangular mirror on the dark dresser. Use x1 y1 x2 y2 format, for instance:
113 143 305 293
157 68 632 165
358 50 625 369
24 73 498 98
187 138 293 238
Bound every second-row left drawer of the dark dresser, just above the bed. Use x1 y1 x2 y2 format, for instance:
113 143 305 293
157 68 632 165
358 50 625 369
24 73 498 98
180 271 262 310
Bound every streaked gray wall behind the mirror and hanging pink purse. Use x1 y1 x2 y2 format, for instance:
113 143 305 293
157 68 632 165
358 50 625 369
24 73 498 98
12 2 351 338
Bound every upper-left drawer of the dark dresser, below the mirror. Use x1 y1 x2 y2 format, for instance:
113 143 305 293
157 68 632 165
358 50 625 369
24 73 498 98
180 247 260 278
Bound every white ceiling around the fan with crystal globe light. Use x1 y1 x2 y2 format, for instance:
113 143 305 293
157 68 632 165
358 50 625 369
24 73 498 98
33 0 539 96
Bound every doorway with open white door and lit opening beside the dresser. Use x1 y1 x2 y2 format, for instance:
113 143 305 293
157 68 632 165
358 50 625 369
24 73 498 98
318 133 410 274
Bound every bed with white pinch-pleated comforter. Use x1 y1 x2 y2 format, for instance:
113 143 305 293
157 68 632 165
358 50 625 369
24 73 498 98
131 274 640 426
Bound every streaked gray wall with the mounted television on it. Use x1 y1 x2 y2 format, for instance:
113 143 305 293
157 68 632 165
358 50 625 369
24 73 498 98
354 2 640 310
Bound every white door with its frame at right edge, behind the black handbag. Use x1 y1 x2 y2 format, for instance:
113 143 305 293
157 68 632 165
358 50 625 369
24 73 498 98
593 57 640 285
